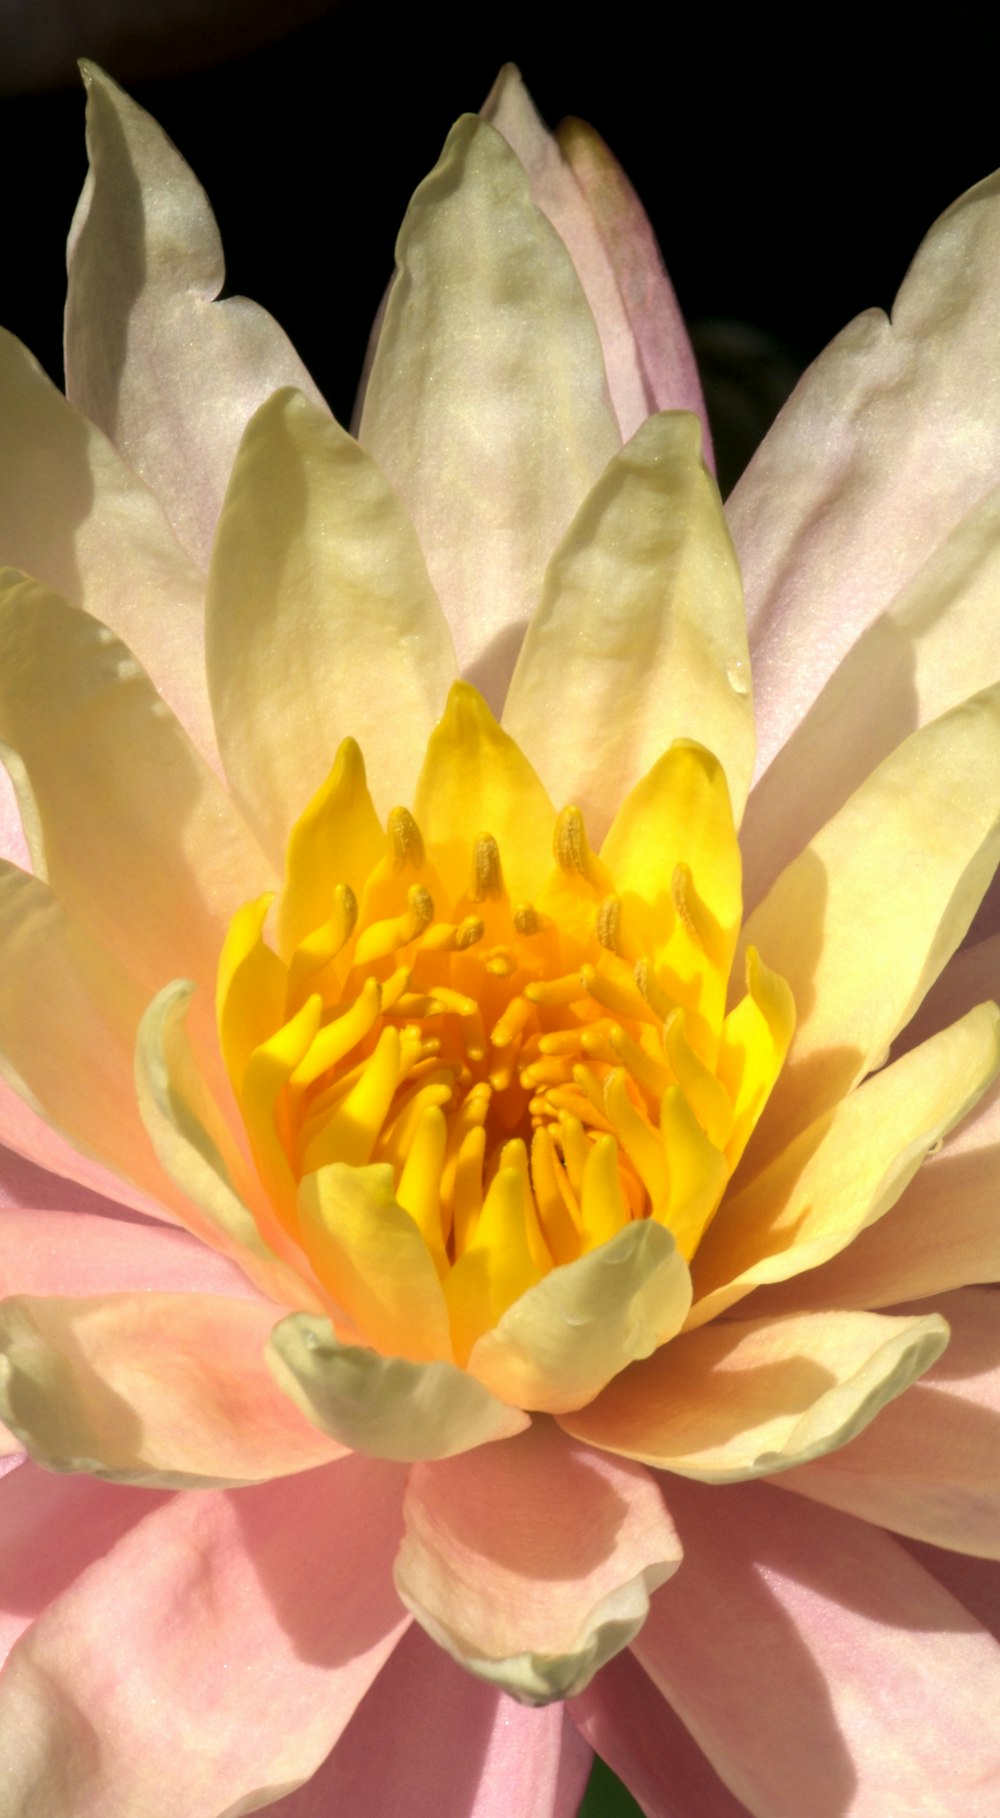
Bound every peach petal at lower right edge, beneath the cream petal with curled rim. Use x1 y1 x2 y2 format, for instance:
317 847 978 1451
782 1287 1000 1560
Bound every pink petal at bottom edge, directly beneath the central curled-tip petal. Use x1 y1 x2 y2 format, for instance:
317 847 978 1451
267 1625 591 1818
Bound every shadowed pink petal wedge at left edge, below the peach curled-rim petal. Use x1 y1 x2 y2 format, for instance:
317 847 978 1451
0 1458 167 1663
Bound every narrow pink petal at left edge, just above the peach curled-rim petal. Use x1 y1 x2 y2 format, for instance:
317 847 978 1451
0 1199 267 1300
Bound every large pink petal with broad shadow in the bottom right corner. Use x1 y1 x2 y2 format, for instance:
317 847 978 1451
633 1478 1000 1818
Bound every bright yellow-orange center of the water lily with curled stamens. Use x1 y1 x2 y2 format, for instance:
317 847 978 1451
218 690 793 1362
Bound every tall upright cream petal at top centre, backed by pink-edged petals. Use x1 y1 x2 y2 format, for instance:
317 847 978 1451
360 115 618 711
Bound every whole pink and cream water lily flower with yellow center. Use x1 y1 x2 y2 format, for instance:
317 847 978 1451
0 56 1000 1818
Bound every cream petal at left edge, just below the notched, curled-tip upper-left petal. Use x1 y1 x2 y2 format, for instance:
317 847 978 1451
0 329 218 763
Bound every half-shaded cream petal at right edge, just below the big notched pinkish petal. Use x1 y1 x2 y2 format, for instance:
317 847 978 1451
744 489 1000 909
